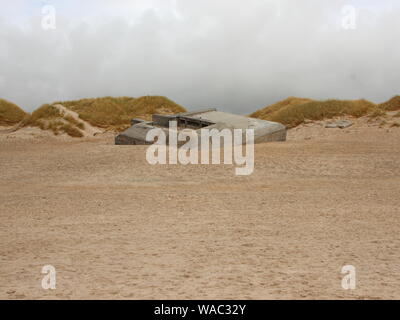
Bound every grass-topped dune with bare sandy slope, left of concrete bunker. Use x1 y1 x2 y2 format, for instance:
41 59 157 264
12 96 186 137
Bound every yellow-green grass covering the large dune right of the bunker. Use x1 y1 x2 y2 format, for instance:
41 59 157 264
251 98 382 128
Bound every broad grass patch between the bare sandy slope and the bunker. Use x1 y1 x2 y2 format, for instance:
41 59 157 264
55 96 186 129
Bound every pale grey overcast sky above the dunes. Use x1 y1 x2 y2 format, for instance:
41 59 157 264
0 0 400 114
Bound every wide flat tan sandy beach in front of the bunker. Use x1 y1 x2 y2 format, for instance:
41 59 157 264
0 121 400 299
